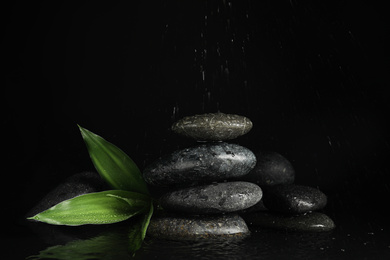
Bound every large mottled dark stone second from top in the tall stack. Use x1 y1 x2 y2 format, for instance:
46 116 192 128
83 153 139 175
143 143 256 187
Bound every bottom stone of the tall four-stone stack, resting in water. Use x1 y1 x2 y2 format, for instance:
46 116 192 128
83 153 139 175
147 215 249 240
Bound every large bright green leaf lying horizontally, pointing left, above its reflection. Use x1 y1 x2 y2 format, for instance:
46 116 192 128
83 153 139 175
29 190 150 226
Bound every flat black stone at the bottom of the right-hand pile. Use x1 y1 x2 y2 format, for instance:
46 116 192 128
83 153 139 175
244 212 335 232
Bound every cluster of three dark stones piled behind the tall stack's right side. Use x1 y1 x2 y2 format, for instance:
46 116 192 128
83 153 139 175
244 152 335 231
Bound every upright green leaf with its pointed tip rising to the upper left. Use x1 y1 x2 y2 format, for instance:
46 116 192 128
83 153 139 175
79 126 149 195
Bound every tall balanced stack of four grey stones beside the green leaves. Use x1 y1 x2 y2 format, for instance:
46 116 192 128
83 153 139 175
143 113 262 239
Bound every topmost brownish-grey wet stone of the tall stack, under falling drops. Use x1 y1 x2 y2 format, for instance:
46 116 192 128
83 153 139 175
172 113 253 141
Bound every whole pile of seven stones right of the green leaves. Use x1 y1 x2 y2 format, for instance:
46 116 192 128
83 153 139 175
143 113 334 239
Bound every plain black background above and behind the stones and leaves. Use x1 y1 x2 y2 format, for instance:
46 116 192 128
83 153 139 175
2 1 390 258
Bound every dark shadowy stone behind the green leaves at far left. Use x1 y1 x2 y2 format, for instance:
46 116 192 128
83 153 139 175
26 172 108 217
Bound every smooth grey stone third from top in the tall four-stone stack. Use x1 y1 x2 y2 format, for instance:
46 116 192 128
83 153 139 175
160 182 263 215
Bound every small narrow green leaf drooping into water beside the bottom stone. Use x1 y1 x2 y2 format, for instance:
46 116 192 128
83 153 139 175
129 201 153 253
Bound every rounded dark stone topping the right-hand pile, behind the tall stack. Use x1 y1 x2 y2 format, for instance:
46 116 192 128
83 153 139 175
242 152 295 187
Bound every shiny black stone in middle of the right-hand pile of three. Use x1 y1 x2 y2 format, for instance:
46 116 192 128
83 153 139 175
263 184 327 214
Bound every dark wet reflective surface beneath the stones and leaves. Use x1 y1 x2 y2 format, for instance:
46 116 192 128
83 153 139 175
24 213 390 259
